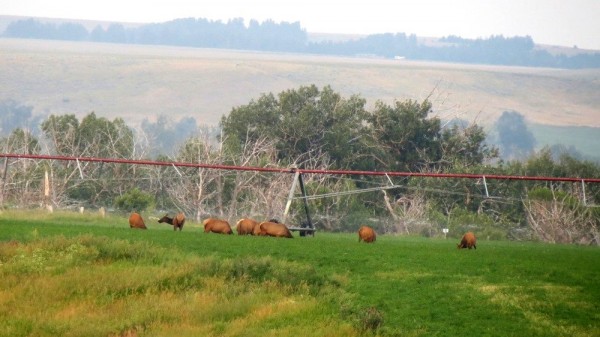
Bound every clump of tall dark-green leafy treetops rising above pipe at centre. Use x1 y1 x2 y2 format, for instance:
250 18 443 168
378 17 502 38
221 85 496 175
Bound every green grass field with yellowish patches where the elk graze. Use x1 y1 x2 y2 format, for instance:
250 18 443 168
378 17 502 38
0 211 600 336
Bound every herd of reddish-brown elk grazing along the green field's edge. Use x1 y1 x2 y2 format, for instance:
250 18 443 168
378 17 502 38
129 212 477 249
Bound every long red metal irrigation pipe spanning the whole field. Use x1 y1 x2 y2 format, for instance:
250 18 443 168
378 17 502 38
0 153 600 183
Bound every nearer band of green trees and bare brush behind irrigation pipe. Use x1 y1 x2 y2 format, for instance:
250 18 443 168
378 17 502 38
0 85 600 243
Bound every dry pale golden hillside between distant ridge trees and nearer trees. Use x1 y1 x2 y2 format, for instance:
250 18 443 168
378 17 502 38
0 39 600 127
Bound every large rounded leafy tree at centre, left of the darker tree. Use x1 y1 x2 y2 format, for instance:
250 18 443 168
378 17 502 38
221 85 366 167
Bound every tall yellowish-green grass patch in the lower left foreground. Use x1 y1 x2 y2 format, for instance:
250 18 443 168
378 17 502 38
0 235 355 336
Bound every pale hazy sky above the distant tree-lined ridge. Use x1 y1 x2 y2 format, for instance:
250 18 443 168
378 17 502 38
0 0 600 50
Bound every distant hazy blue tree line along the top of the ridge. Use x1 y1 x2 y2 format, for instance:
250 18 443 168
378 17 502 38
3 18 600 69
